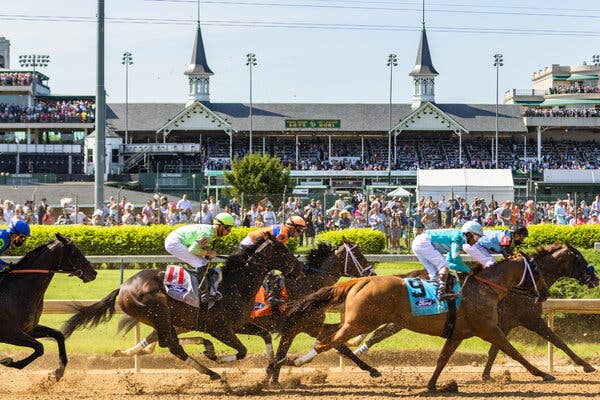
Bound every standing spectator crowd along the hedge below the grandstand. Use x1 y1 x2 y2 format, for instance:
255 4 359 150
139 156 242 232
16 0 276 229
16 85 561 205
0 192 600 254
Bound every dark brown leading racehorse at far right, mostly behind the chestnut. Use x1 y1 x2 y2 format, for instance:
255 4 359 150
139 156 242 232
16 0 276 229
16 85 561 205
356 244 599 380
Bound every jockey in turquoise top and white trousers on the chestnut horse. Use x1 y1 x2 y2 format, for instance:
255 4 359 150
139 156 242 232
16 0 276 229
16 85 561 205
412 221 483 300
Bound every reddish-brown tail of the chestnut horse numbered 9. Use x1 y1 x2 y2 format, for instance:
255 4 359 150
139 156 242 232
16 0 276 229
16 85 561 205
277 279 361 332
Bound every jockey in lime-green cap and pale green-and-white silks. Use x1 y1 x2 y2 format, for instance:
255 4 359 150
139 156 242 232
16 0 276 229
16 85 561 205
165 212 235 300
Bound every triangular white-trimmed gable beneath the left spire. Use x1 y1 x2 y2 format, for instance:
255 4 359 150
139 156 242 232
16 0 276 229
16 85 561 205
156 101 237 136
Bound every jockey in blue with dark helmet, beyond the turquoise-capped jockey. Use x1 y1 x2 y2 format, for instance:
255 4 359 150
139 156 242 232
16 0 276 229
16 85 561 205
461 221 529 268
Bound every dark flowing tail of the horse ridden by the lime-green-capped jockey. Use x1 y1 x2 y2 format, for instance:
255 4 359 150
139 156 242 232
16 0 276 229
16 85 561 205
61 289 119 338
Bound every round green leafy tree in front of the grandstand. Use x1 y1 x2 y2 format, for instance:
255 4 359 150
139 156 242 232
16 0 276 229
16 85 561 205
224 153 293 208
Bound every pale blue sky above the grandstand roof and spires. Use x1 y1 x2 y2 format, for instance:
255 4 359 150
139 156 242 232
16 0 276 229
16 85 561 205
0 0 600 104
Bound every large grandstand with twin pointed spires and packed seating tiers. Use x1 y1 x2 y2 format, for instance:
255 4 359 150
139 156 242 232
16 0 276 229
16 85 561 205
0 22 600 200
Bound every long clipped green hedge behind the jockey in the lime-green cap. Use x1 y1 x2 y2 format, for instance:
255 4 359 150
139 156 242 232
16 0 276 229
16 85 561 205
4 225 298 256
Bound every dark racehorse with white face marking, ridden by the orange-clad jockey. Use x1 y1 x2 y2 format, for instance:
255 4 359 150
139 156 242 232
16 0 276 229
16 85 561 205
107 238 379 383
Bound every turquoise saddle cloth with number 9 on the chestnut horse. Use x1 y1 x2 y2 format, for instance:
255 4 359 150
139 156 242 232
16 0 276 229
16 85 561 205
404 278 462 316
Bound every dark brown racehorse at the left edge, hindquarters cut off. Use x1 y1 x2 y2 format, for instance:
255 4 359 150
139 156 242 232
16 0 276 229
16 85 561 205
0 233 96 381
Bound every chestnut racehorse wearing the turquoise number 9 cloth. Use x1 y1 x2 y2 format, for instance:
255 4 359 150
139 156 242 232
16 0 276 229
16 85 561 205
281 256 555 390
